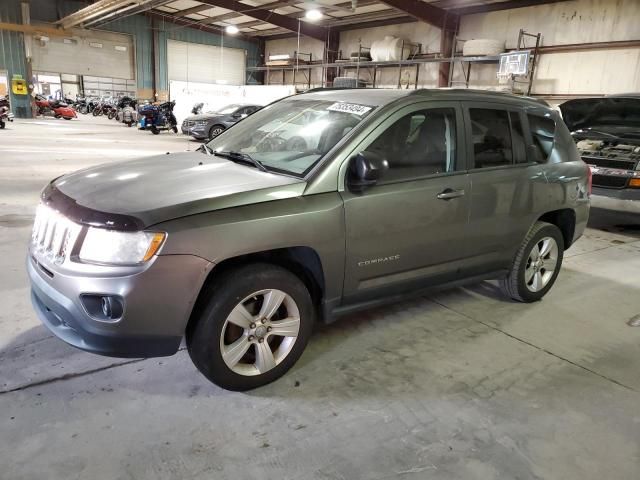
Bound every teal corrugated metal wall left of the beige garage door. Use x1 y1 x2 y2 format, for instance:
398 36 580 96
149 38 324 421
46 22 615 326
0 0 31 118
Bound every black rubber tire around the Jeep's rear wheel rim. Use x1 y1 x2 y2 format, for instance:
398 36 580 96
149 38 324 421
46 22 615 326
500 222 564 303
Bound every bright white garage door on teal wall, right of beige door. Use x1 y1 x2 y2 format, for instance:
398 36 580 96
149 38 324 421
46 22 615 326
167 40 246 85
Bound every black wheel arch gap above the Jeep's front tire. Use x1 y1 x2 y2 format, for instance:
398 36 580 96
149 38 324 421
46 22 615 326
187 246 325 331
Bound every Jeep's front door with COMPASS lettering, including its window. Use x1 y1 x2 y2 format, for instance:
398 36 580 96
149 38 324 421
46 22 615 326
341 102 470 303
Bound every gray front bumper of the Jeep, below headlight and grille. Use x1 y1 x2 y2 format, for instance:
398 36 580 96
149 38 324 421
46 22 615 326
27 255 211 358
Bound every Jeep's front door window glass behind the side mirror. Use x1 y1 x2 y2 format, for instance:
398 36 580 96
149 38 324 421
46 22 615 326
367 108 456 184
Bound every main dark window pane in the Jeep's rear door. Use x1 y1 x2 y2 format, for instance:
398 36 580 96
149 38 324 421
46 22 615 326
469 108 514 168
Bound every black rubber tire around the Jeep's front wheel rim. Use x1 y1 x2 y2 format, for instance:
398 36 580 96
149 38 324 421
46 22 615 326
186 263 315 391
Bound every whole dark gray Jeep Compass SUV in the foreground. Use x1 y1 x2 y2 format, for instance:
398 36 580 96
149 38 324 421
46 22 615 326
27 89 590 390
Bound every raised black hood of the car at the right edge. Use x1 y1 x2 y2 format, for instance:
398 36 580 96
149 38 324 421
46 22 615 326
560 96 640 131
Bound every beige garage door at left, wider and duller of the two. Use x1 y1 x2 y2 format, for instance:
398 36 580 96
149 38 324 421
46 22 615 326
33 32 135 80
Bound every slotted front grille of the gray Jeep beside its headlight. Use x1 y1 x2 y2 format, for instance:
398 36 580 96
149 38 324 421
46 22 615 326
31 205 81 264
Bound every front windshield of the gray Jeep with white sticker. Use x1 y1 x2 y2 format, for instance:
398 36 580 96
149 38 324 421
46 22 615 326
207 98 373 176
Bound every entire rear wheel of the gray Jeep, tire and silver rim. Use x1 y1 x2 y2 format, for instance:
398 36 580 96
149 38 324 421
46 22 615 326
501 222 564 303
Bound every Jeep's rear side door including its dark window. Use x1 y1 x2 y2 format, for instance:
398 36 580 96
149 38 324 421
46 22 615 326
464 102 547 270
